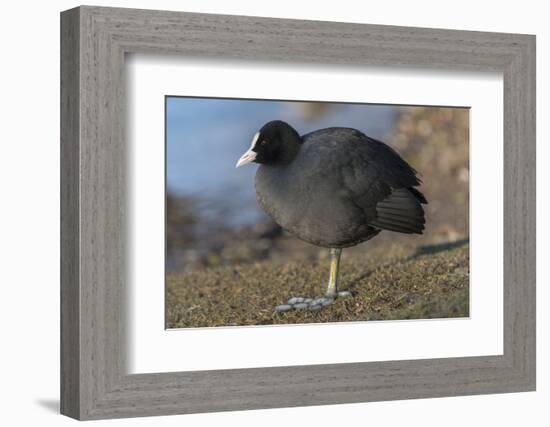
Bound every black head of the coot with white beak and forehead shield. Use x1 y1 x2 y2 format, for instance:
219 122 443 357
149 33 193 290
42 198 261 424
235 120 302 168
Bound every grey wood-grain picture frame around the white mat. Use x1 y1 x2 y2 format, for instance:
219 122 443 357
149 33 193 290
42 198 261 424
61 6 535 419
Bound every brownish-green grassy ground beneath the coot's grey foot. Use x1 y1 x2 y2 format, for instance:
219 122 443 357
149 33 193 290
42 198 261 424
166 241 469 328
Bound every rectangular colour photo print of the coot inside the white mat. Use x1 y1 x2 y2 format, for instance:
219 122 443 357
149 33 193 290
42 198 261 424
164 98 470 329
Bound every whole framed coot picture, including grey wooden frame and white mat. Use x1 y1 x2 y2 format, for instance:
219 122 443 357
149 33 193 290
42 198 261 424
61 6 535 420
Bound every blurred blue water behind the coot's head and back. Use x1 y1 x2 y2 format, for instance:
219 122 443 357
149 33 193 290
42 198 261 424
166 97 399 226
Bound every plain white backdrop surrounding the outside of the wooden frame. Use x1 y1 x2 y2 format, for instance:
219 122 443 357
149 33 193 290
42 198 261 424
0 0 550 427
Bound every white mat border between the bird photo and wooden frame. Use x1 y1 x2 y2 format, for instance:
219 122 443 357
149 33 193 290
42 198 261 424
126 55 503 373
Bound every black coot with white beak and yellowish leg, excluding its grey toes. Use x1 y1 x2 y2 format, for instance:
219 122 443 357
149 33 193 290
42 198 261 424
236 120 427 308
